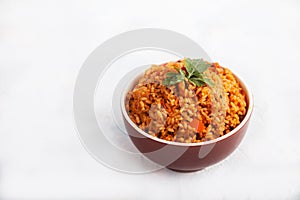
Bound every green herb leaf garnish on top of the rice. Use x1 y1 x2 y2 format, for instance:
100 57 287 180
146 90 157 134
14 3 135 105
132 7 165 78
163 58 214 86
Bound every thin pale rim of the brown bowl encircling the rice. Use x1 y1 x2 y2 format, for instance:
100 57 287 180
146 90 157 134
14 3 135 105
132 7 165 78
120 66 254 147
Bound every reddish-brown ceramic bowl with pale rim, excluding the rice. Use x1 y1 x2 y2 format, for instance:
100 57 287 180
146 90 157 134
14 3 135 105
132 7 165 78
121 69 253 172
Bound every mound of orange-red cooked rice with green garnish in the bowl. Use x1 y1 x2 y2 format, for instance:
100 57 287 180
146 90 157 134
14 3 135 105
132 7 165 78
125 58 248 143
